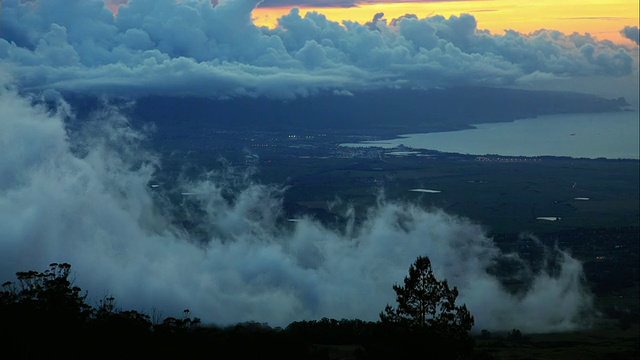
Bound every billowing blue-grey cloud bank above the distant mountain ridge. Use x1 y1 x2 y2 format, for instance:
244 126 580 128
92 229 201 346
0 0 637 98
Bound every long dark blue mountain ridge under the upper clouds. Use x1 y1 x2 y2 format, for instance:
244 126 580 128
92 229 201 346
61 87 629 135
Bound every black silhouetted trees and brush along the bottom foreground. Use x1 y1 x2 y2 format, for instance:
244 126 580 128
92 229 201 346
0 256 490 359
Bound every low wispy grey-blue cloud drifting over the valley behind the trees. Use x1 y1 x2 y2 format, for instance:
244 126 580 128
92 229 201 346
0 86 591 332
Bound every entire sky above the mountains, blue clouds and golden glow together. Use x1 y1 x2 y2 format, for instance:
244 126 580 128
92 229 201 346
0 0 638 101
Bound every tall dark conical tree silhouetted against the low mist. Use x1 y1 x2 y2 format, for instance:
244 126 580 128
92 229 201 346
380 256 474 337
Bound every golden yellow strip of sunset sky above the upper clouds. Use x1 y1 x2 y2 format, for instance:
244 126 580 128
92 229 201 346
253 0 639 43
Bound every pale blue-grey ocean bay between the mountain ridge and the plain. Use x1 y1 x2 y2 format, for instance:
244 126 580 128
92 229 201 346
342 111 640 159
